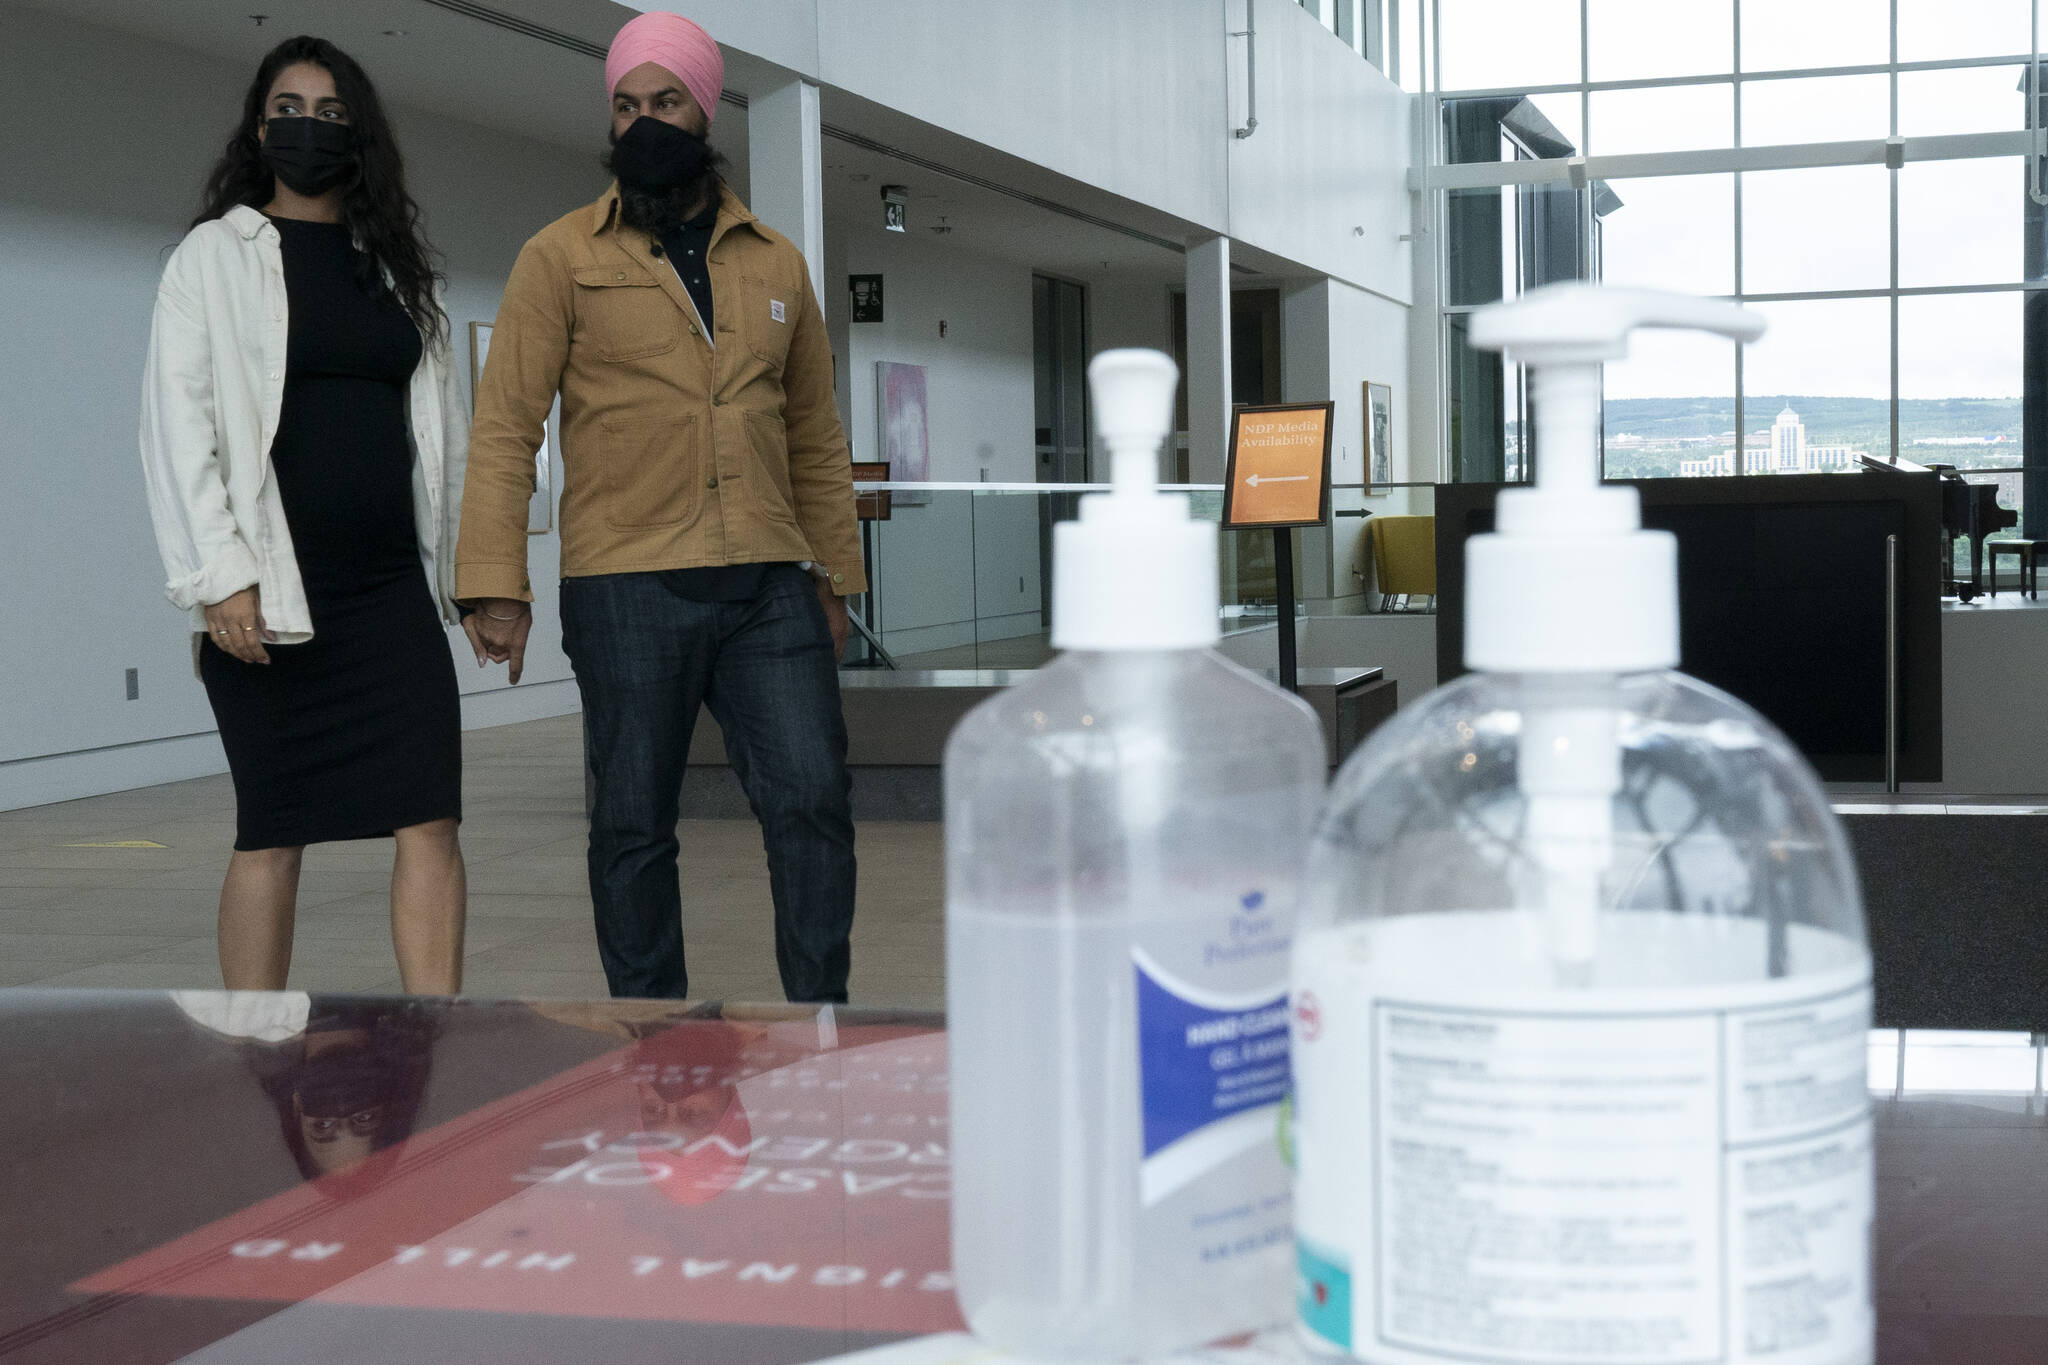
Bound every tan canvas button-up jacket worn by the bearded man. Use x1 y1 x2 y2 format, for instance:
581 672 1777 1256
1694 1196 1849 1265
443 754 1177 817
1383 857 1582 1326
455 184 866 602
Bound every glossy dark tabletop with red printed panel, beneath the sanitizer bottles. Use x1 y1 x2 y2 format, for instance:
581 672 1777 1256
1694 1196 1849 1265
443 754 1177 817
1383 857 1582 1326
0 990 2048 1365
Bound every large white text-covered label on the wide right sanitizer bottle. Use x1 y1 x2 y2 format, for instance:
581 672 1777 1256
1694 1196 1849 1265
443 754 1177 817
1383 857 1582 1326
1294 916 1872 1365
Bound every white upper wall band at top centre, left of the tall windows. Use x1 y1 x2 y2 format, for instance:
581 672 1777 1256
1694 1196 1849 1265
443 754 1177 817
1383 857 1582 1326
631 0 1411 301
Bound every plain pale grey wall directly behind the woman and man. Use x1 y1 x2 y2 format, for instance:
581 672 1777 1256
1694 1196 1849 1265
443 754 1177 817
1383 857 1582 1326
0 8 602 808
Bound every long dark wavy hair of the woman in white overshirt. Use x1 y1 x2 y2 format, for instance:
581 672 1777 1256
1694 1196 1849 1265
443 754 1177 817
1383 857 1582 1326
193 37 449 344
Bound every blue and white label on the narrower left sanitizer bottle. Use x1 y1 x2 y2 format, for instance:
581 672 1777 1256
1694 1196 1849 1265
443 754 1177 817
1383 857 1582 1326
1133 950 1288 1203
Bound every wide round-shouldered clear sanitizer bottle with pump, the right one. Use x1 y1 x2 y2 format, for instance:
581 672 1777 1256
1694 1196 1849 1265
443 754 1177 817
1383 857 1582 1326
1292 284 1872 1365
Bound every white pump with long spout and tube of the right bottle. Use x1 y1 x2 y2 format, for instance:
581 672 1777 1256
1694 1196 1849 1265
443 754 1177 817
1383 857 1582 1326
1464 284 1763 986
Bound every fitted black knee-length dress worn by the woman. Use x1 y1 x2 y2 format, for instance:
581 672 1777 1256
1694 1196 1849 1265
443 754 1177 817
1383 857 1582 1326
199 219 463 849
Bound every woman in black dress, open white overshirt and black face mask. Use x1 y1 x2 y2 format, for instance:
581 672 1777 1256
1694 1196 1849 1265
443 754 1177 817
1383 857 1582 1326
141 37 485 993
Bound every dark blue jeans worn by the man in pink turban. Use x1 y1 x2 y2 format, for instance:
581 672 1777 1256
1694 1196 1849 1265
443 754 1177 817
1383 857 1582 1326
561 565 854 1001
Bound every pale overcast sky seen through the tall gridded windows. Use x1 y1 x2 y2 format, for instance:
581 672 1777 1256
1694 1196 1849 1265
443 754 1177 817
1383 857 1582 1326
1403 0 2034 403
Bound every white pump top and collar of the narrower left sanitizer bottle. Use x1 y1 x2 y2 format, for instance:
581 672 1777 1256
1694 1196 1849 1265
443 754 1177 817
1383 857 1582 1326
1053 350 1221 649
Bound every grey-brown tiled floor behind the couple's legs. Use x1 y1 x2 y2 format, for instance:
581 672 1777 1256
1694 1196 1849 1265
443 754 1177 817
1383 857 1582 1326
0 716 944 1009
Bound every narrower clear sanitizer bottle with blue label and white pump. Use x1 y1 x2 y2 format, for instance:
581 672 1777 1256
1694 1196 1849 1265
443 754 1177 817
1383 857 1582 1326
944 350 1329 1361
